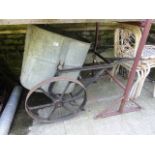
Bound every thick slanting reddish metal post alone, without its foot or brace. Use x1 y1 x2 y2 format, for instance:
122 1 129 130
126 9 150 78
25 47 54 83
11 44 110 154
118 19 152 113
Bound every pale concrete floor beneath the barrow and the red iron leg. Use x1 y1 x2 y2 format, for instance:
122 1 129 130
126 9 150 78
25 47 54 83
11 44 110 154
10 75 155 135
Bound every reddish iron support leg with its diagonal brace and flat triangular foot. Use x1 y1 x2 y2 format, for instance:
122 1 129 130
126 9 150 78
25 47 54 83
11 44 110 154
95 19 152 118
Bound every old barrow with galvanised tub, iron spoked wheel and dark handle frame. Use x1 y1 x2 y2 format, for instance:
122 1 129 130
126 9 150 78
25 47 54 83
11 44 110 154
20 25 118 122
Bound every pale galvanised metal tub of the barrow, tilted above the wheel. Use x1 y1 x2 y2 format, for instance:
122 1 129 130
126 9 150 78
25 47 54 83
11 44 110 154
20 25 90 93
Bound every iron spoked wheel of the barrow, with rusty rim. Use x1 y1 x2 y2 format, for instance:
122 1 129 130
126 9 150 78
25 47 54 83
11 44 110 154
25 77 87 123
